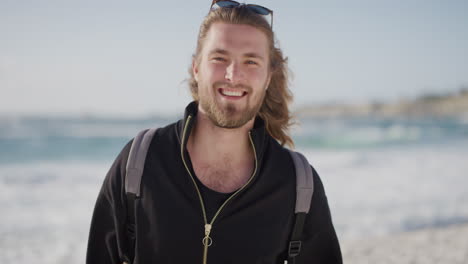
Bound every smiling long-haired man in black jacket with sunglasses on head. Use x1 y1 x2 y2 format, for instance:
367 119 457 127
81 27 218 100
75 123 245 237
87 1 342 264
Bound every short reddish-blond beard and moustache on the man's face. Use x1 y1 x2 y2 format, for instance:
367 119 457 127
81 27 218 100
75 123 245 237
199 82 266 129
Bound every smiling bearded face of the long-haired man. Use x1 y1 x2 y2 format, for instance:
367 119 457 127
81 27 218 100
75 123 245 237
193 23 270 128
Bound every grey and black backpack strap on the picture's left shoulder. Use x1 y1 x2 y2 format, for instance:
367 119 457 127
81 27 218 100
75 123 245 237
123 128 157 264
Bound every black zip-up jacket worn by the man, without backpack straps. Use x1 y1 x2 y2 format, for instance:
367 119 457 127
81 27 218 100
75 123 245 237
86 103 342 264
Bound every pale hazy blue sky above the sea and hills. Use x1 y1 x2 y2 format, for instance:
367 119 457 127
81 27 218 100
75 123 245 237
0 0 468 115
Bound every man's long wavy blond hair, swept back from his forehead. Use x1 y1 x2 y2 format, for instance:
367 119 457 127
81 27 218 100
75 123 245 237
189 5 294 147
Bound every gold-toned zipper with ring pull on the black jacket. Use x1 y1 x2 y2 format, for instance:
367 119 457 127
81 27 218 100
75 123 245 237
180 115 258 264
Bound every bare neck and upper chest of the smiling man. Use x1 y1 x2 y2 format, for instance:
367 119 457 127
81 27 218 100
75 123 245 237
187 108 255 193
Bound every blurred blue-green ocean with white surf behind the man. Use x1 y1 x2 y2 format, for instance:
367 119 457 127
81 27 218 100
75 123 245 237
0 115 468 264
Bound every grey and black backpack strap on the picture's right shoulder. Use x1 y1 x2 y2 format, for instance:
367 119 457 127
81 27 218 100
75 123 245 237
285 150 314 264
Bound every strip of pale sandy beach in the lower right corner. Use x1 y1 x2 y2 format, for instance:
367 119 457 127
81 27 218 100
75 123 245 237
341 224 468 264
